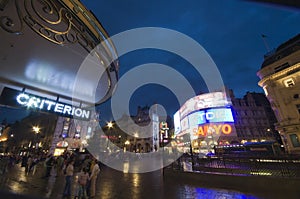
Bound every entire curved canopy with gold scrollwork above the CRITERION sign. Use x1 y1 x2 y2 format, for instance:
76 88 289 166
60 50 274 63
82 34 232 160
0 0 118 105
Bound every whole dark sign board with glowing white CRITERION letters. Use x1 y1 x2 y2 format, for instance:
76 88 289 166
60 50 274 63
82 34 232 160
0 88 91 120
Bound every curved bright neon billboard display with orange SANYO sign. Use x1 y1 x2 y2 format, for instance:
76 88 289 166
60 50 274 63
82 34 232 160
174 92 235 140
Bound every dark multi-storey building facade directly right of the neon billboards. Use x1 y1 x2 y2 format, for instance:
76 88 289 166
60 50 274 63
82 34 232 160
229 90 278 143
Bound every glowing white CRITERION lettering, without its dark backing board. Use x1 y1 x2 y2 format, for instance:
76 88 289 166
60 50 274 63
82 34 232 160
16 93 91 120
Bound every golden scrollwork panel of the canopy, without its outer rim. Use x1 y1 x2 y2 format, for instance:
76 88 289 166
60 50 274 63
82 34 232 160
0 0 99 52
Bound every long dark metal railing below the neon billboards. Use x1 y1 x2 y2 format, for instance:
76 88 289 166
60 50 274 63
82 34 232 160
172 156 300 178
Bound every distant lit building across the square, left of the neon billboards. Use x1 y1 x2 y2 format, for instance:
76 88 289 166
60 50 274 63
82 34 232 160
100 106 170 153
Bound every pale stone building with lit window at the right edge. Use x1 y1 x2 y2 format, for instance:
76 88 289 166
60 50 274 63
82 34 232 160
257 34 300 154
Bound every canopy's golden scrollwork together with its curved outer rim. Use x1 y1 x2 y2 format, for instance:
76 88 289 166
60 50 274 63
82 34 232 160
0 0 118 103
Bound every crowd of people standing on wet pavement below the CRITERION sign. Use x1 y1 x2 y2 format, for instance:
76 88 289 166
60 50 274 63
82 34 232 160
0 152 100 199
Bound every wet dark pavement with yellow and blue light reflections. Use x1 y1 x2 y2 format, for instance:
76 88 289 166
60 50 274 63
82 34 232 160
0 163 292 199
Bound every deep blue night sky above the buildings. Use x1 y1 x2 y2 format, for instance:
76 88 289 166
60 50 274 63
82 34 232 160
0 0 300 121
